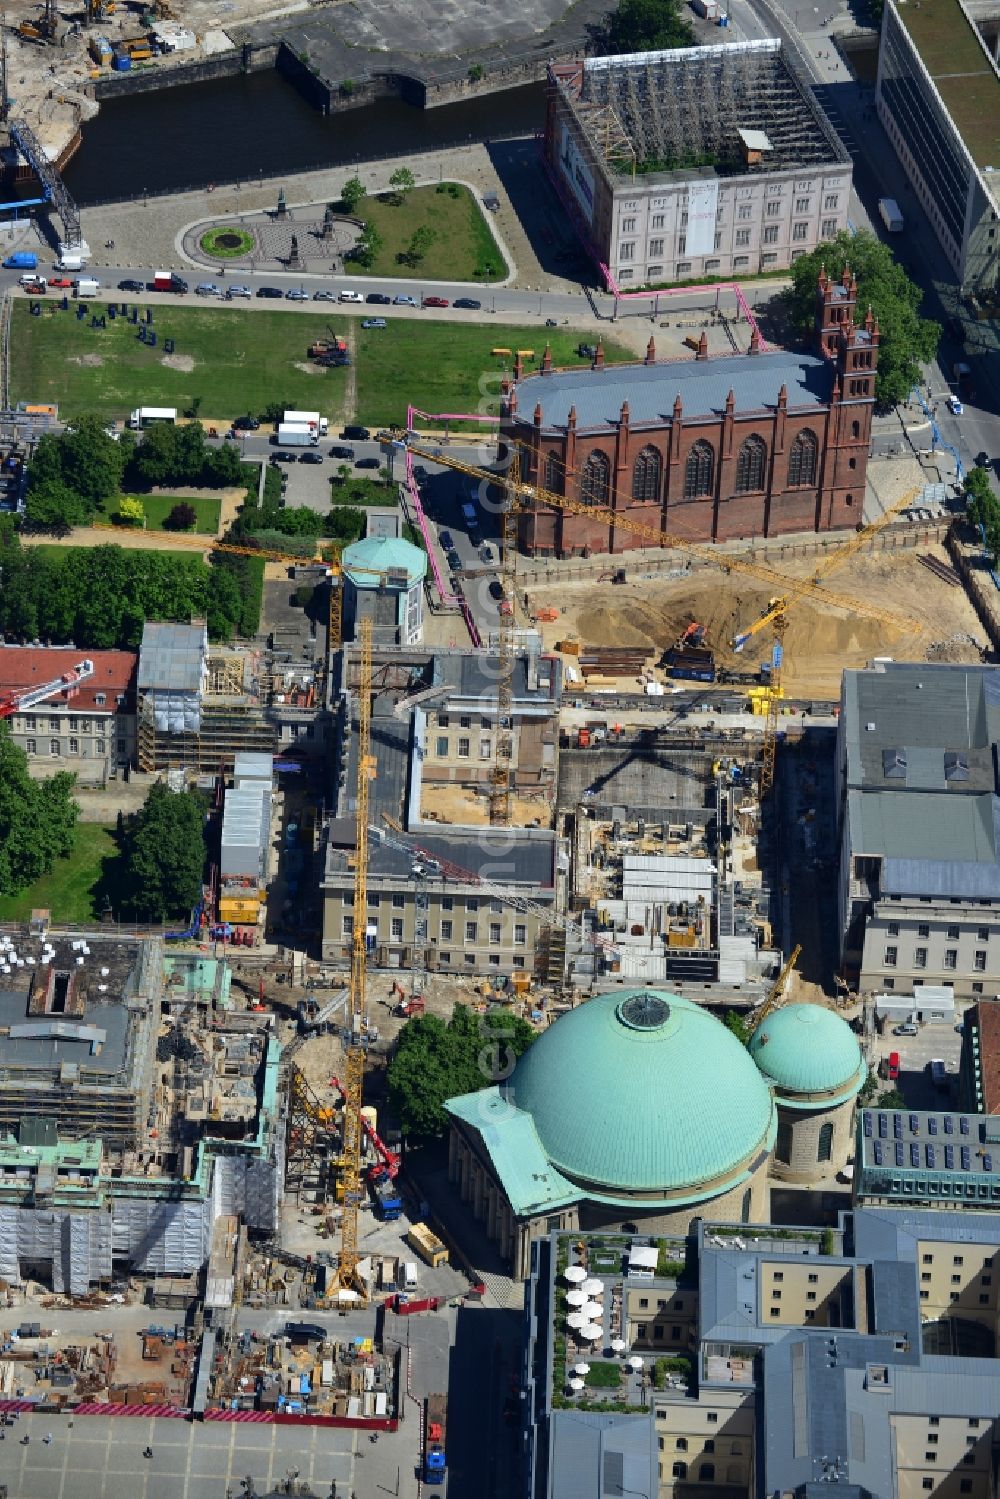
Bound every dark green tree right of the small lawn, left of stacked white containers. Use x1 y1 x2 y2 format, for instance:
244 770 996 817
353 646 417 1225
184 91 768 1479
123 781 205 922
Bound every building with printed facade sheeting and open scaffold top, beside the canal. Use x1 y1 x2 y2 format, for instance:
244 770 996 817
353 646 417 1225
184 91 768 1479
544 40 852 289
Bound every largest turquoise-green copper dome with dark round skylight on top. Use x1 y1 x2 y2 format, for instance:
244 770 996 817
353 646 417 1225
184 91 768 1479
502 989 774 1195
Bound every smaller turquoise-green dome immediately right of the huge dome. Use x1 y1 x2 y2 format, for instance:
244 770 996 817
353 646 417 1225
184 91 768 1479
750 1004 868 1106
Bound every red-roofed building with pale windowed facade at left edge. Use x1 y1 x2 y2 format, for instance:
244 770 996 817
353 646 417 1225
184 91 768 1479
0 645 138 781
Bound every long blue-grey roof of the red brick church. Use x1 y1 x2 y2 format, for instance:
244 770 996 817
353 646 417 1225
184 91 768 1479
517 349 835 432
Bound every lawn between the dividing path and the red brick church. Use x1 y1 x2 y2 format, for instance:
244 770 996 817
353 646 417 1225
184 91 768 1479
355 320 636 426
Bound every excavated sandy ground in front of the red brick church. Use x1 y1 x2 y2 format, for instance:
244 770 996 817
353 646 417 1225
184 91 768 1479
530 546 987 699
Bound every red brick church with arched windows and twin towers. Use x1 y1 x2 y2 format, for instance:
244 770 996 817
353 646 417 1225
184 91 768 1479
501 268 879 558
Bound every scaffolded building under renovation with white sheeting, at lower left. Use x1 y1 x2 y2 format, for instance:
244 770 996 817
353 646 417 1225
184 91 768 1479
0 922 283 1295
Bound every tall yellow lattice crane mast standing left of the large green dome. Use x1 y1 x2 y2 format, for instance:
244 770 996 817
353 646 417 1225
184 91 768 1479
339 619 375 1301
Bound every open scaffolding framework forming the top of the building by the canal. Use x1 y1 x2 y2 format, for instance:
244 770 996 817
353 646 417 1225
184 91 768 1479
561 40 843 175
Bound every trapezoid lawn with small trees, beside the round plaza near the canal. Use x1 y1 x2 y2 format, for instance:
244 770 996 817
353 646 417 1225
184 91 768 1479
343 183 507 282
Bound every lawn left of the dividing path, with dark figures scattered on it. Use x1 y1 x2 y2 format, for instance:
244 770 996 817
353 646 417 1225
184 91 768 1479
10 301 348 424
